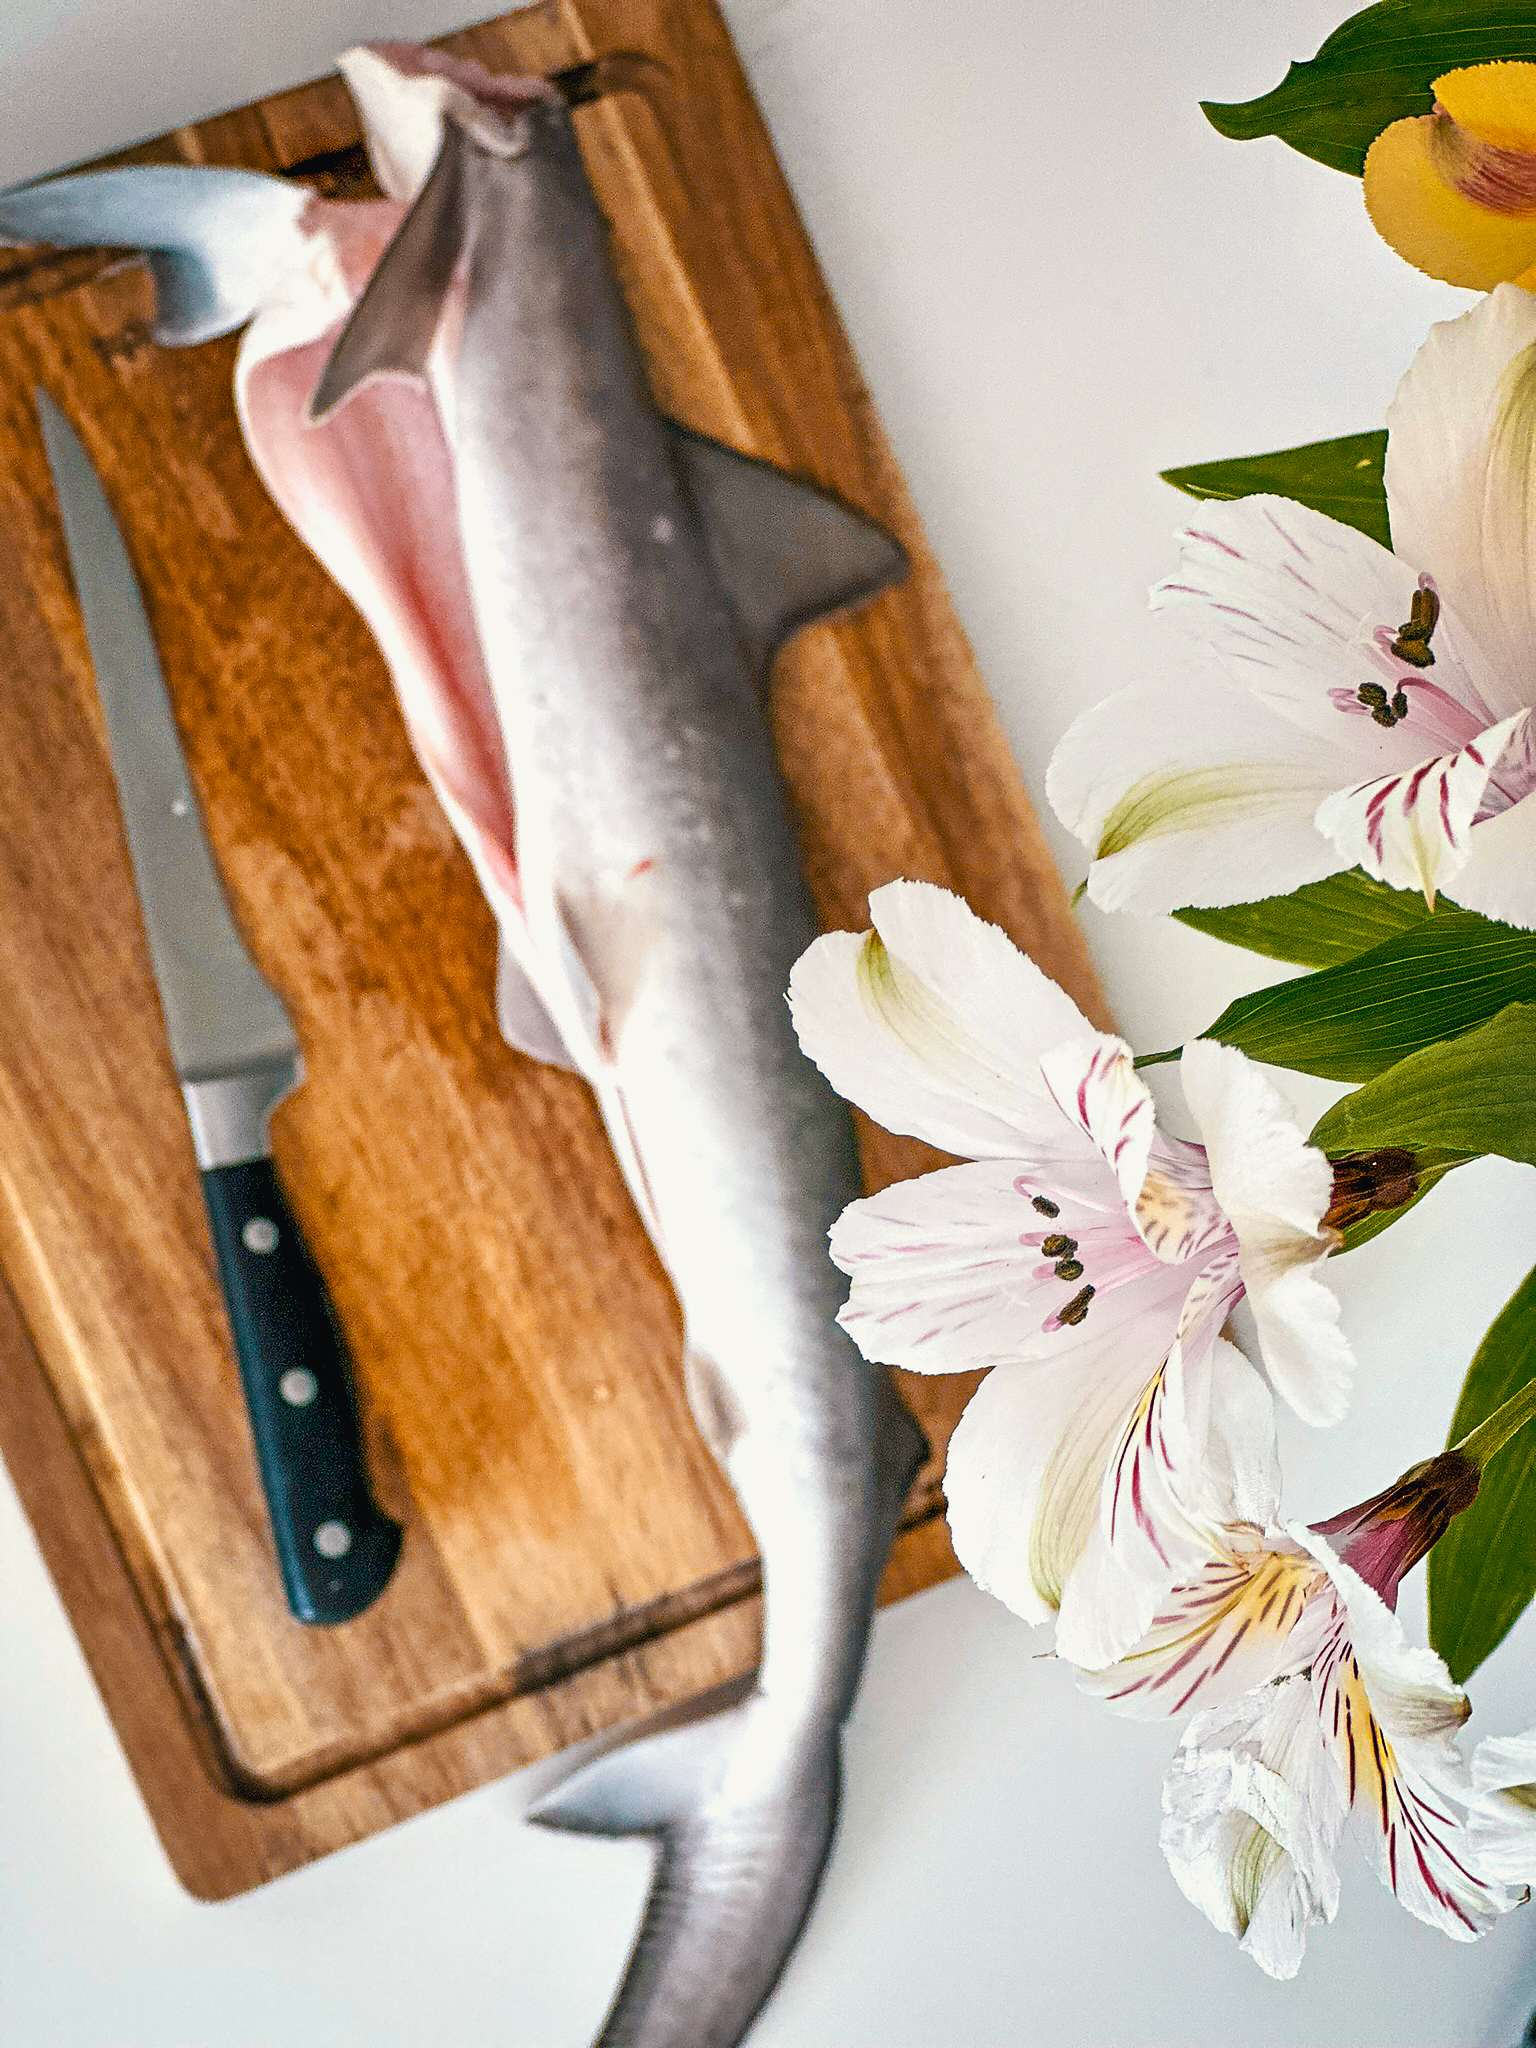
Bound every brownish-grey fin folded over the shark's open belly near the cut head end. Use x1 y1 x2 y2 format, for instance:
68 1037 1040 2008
309 121 467 426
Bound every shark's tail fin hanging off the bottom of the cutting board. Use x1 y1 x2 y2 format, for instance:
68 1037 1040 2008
528 1694 840 2048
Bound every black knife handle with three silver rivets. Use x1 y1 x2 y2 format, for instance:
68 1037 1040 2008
203 1159 401 1622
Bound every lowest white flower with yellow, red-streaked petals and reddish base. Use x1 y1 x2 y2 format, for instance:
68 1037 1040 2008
1079 1452 1536 1976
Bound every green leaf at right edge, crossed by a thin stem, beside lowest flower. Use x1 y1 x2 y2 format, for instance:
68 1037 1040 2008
1430 1272 1536 1686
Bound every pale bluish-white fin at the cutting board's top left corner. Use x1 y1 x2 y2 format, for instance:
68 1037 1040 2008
0 164 313 348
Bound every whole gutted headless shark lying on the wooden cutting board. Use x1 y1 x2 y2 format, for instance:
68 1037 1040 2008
0 45 926 2048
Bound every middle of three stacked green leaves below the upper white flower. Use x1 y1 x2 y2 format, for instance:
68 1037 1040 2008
1204 909 1536 1081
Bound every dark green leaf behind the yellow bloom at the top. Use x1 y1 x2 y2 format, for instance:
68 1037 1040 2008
1202 0 1536 176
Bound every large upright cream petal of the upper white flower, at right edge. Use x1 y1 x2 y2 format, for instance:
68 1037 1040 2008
1386 285 1536 704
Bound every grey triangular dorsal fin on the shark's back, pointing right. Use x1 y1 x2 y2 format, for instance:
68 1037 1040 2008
672 424 907 670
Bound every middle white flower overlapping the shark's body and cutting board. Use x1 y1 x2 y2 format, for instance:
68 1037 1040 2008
791 883 1352 1663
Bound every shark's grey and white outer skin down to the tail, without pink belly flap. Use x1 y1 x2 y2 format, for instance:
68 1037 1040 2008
313 106 924 2048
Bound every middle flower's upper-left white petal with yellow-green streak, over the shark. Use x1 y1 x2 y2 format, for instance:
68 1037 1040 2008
788 883 1090 1159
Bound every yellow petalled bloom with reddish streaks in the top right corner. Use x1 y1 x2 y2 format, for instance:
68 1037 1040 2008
1362 61 1536 291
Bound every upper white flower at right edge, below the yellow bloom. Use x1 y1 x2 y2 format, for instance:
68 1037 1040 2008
1047 287 1536 926
